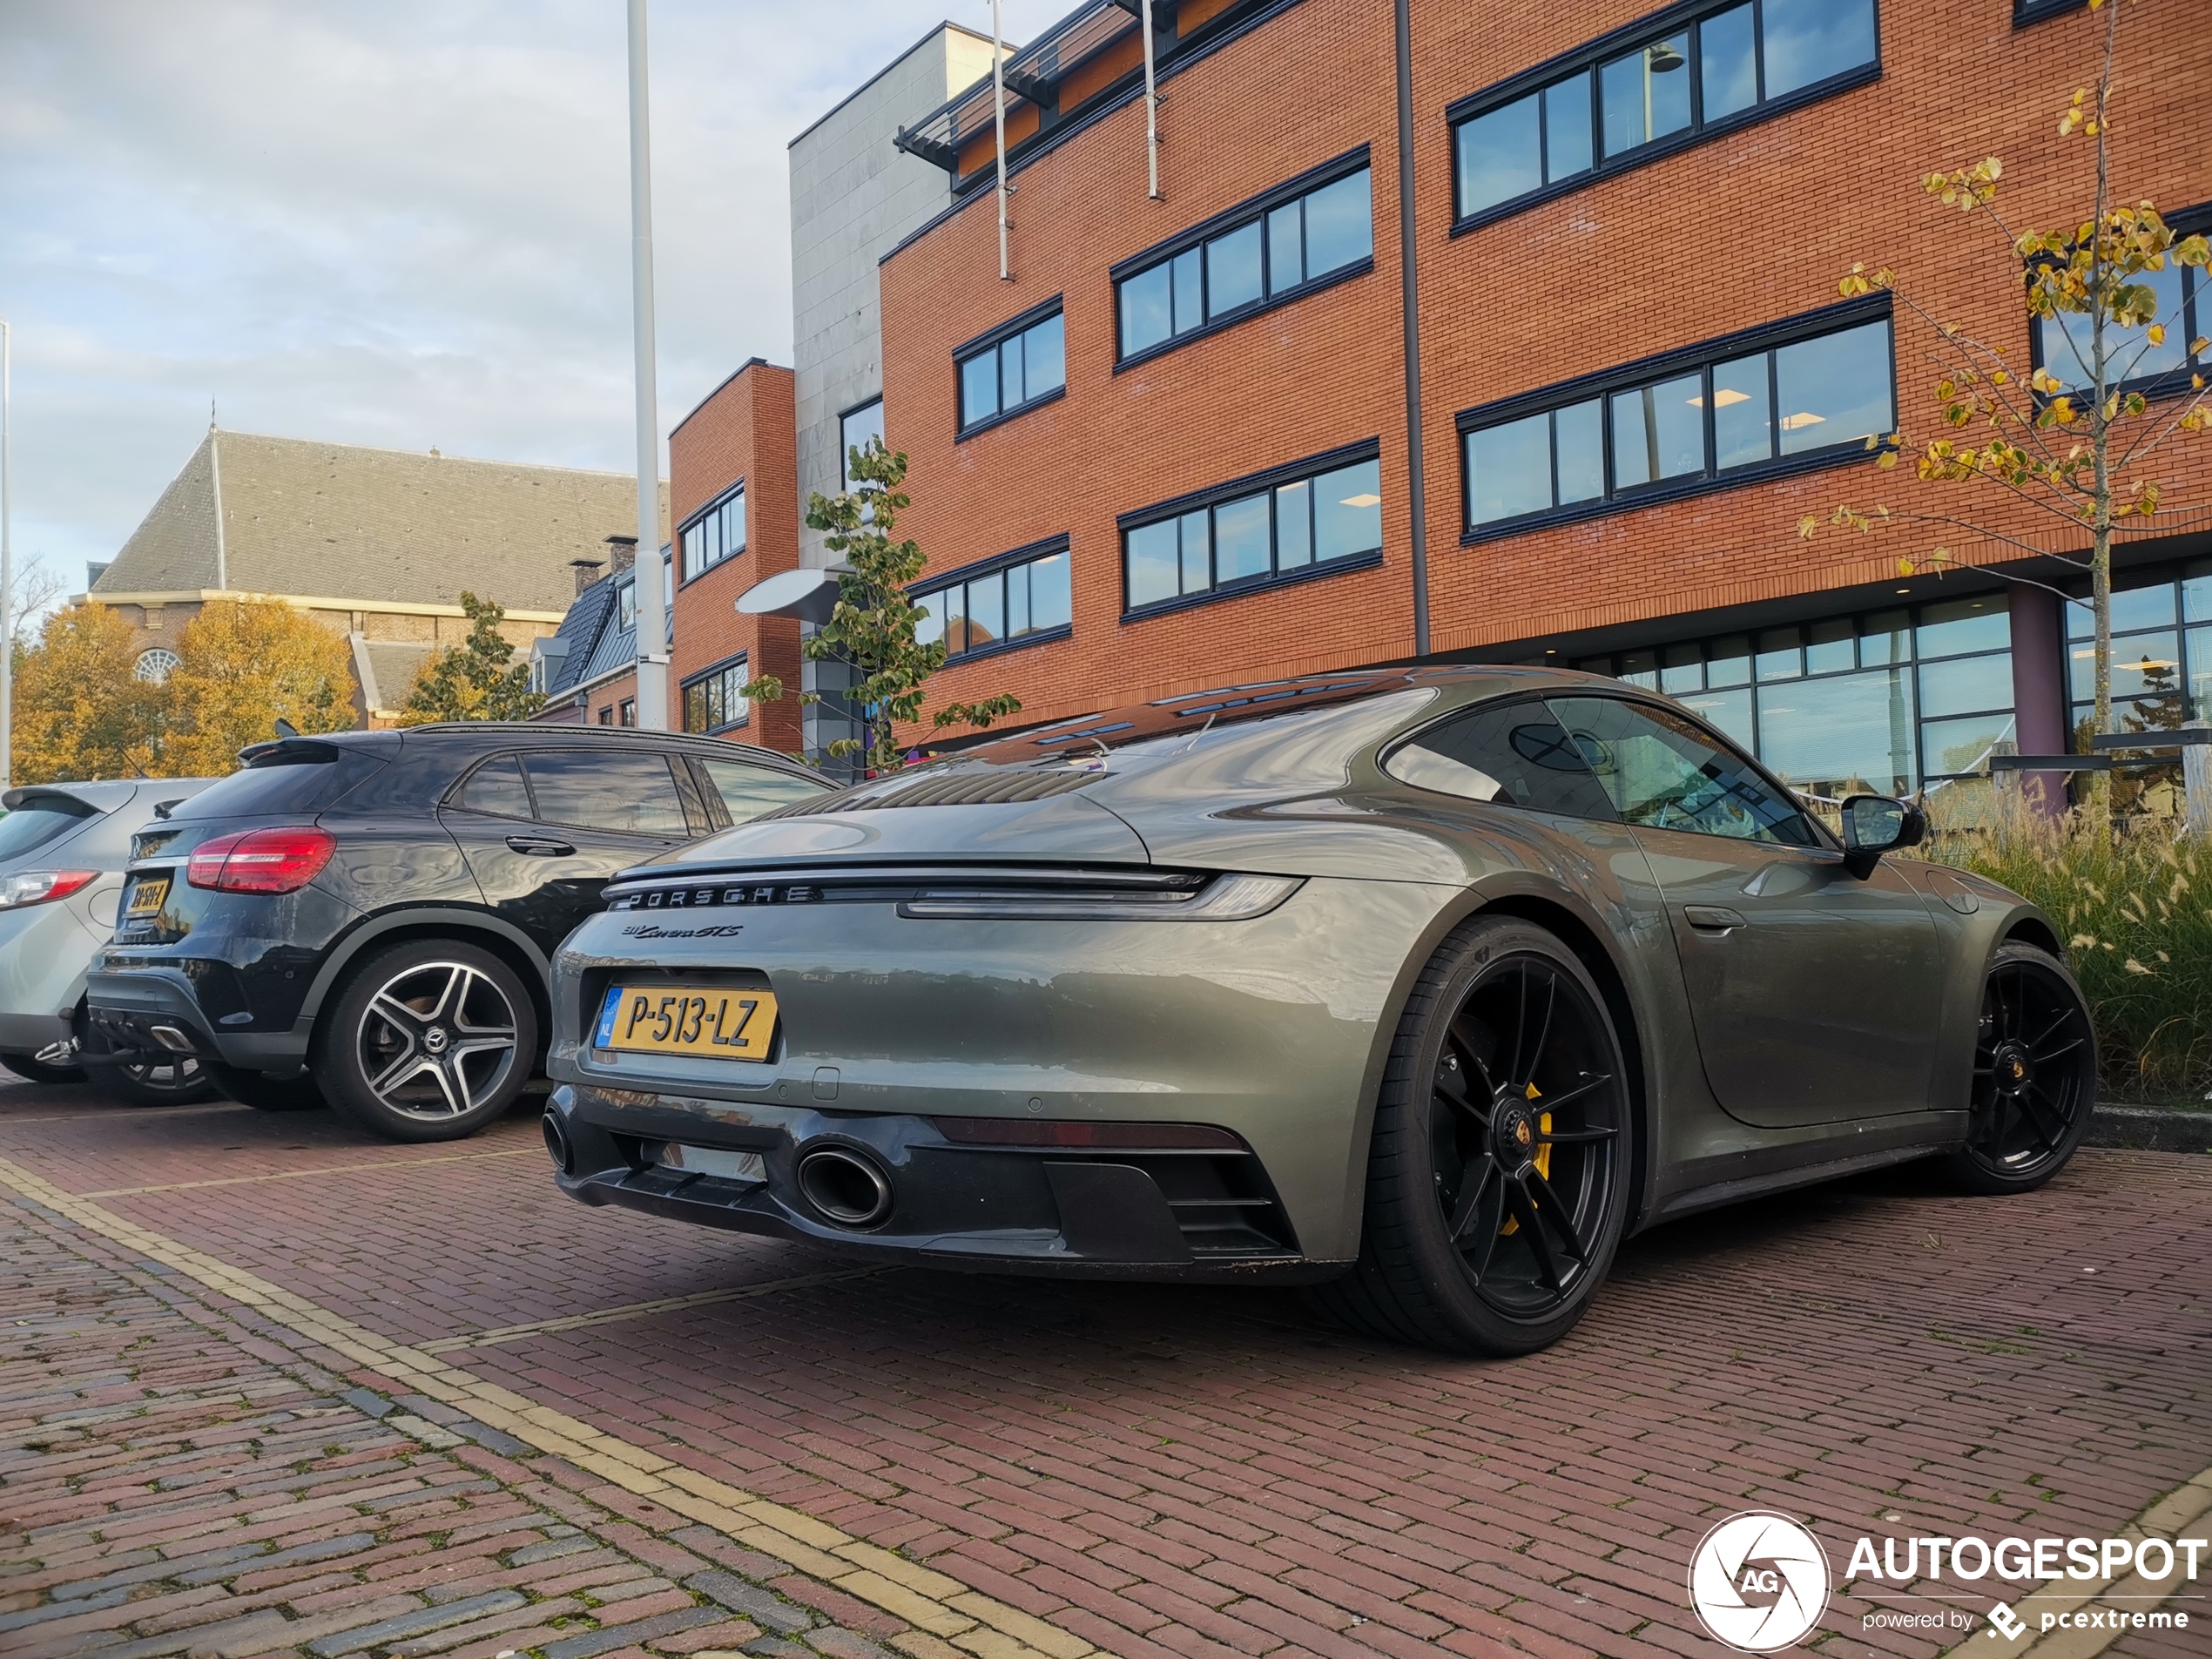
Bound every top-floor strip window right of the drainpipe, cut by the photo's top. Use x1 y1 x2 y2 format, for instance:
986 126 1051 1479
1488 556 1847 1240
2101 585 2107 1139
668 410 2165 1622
1449 0 1878 221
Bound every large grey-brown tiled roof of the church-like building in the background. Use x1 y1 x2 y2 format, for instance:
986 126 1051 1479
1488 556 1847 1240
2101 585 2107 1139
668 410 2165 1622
93 429 666 613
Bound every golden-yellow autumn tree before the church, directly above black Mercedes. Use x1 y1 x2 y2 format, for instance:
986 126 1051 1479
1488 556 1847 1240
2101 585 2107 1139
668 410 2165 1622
148 599 354 777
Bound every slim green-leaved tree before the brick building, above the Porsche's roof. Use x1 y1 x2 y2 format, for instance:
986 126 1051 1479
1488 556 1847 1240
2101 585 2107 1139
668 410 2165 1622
745 438 1022 772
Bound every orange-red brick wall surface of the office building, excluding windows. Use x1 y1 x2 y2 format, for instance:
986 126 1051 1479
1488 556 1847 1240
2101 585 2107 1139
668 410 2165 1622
882 0 2212 738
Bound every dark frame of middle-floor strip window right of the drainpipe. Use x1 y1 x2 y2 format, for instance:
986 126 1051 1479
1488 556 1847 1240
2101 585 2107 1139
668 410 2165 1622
1453 292 1898 546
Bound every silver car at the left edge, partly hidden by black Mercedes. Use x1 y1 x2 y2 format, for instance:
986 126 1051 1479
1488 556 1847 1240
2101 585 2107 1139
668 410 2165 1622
0 779 212 1103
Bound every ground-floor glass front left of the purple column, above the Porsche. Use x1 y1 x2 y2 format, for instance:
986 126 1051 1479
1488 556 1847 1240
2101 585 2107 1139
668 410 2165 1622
1575 597 2026 799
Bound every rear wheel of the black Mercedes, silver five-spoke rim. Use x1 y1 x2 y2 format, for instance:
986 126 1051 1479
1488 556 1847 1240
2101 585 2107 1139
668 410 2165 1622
314 941 537 1142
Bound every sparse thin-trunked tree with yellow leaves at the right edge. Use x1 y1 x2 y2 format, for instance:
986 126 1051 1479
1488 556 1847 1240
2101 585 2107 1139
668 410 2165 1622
1798 0 2212 816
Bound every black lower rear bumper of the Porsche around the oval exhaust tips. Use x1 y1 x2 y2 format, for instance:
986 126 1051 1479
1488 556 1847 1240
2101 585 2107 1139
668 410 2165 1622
546 1086 1349 1283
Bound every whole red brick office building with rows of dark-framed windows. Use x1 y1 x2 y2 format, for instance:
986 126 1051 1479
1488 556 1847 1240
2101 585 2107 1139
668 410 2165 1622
880 0 2212 790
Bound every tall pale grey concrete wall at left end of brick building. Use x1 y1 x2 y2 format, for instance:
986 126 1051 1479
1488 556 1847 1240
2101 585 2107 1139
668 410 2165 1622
790 22 991 566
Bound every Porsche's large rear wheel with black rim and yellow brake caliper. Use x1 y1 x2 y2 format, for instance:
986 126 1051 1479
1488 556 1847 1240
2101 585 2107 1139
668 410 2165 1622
1310 916 1633 1356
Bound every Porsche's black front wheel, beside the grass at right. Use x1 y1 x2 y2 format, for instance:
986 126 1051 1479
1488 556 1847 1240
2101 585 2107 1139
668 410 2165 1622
1945 941 2097 1195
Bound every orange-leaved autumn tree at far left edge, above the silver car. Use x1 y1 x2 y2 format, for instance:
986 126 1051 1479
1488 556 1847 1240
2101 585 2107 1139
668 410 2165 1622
13 604 163 783
